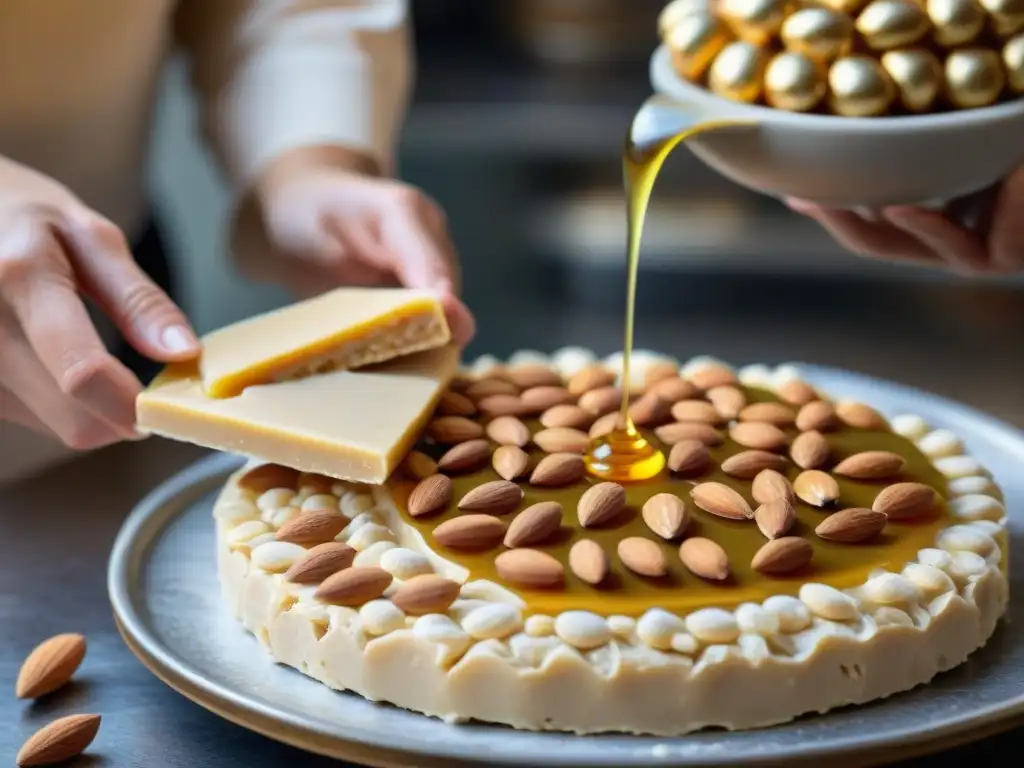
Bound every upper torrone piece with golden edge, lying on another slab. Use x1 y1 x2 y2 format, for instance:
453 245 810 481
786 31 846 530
200 288 451 397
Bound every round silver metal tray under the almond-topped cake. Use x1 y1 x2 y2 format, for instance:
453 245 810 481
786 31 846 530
109 366 1024 768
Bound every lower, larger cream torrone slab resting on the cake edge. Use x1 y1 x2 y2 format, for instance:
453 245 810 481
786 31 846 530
136 346 459 484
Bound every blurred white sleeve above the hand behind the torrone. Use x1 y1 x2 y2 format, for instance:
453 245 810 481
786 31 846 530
176 0 413 191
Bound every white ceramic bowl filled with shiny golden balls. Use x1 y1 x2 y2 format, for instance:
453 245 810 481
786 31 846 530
650 45 1024 208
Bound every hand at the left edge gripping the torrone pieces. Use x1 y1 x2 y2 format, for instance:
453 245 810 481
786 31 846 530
0 158 199 450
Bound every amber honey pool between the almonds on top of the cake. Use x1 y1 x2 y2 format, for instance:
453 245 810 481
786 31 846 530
388 388 950 615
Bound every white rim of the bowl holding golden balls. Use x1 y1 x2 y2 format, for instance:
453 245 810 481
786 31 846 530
649 42 1024 133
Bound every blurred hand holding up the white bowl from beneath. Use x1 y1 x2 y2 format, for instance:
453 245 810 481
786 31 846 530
786 167 1024 275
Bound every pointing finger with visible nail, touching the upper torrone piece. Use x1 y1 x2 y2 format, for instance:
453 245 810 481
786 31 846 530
59 211 200 362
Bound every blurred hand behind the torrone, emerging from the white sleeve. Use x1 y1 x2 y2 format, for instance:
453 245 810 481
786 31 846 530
249 146 475 345
